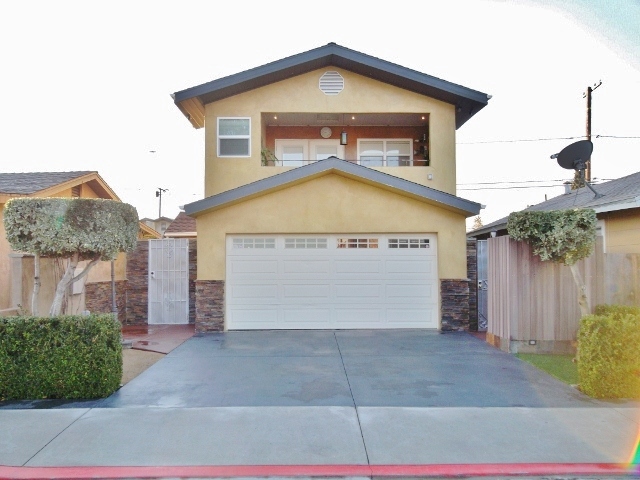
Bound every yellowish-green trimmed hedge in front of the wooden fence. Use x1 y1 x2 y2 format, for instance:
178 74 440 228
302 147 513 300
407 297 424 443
578 307 640 399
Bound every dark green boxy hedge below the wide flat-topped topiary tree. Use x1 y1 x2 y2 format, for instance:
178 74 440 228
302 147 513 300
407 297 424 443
0 314 122 400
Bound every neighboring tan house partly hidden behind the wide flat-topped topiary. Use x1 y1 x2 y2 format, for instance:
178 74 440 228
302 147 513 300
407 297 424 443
0 171 149 314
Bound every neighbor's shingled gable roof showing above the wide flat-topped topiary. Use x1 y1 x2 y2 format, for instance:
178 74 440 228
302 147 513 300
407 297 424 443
0 171 119 200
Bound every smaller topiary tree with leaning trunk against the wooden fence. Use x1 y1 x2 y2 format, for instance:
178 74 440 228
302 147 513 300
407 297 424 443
507 208 597 316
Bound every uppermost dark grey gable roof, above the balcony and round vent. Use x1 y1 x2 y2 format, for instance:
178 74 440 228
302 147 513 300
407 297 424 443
172 42 490 128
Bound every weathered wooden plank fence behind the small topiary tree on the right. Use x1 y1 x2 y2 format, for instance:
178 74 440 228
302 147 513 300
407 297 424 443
487 236 640 353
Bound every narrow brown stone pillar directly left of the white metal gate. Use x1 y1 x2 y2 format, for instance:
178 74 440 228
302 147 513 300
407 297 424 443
122 240 149 325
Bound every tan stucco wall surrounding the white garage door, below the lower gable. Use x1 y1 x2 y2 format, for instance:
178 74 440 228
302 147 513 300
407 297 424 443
197 173 467 280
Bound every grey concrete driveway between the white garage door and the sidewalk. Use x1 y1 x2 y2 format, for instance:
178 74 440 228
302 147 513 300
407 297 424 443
100 330 600 408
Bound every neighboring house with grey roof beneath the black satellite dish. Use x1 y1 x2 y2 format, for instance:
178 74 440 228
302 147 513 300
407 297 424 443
468 172 640 253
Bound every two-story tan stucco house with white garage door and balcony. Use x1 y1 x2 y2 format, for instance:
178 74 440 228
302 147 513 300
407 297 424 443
173 43 490 331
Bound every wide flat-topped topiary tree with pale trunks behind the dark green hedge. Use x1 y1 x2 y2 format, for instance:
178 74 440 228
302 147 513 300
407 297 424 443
4 198 139 317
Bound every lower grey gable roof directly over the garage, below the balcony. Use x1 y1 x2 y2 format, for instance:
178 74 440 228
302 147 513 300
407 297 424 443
184 157 480 217
